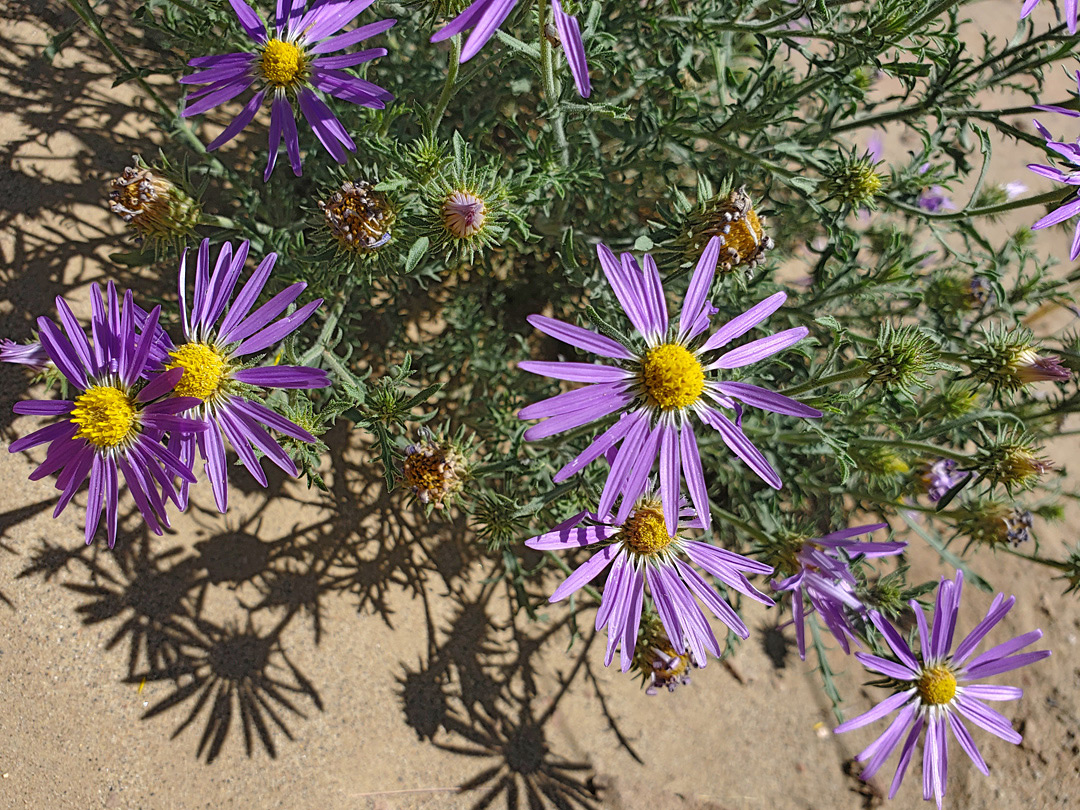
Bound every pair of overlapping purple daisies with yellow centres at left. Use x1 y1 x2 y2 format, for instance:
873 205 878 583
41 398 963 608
6 240 329 548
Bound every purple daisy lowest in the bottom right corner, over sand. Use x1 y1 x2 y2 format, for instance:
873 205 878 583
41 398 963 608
836 572 1050 809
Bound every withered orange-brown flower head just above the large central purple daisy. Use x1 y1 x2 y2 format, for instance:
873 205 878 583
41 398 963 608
686 188 775 272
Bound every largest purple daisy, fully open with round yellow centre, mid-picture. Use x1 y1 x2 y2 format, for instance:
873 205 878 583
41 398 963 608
518 237 821 535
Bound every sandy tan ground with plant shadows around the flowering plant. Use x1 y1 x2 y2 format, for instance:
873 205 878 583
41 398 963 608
0 2 1080 810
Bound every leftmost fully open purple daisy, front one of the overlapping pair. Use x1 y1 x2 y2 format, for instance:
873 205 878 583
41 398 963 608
9 282 203 548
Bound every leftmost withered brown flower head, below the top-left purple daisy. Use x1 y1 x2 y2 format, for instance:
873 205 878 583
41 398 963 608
109 156 202 244
